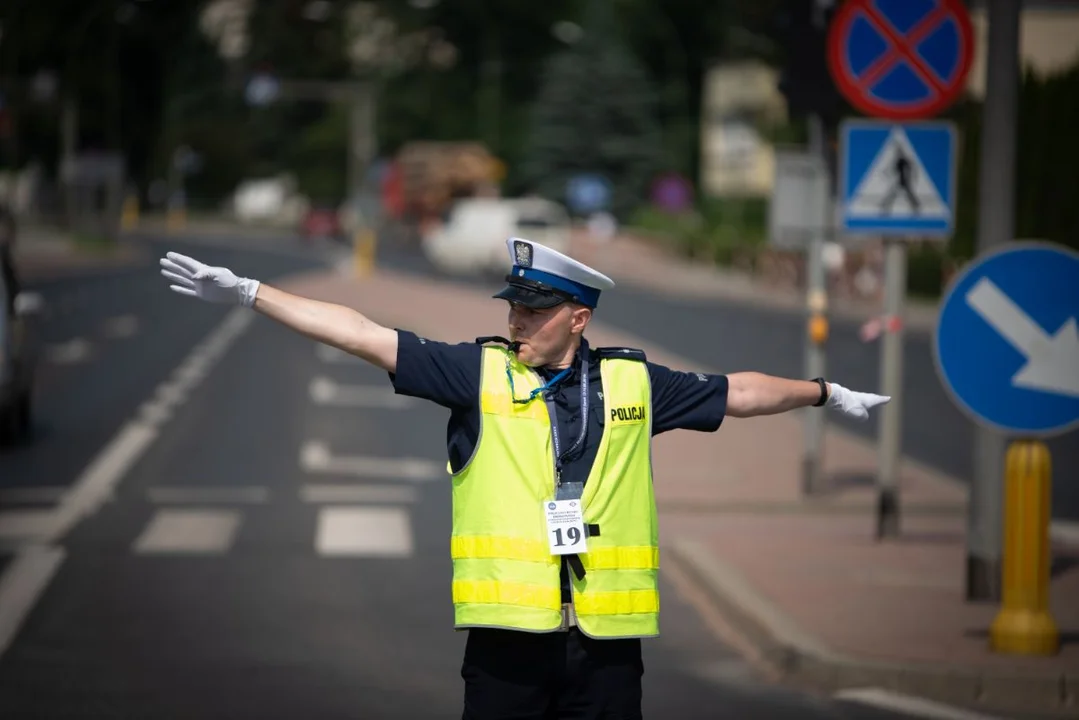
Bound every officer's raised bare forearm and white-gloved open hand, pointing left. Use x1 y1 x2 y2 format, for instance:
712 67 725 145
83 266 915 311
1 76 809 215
161 253 397 372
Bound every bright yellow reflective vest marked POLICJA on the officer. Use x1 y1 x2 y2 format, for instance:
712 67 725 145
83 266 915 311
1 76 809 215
450 347 659 638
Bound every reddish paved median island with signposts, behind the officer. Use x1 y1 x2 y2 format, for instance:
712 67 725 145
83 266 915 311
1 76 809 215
276 264 1079 717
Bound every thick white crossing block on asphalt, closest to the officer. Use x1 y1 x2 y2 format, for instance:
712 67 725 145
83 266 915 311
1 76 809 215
315 507 412 557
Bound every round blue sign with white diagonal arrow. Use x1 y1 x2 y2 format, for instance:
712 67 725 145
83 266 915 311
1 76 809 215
933 243 1079 436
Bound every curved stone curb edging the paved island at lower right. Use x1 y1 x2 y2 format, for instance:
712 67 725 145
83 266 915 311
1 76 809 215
667 540 1079 718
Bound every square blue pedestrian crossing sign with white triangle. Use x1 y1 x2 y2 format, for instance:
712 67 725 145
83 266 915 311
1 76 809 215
838 120 956 239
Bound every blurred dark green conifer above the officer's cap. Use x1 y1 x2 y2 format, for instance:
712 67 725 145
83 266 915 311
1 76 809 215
521 2 663 218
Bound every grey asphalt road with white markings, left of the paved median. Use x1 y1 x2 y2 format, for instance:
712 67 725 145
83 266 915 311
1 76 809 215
0 234 962 720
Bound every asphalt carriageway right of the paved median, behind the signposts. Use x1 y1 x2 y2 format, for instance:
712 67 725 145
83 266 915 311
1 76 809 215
373 241 1079 520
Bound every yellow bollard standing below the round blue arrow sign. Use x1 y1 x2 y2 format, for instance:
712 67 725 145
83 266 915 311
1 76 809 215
989 440 1058 655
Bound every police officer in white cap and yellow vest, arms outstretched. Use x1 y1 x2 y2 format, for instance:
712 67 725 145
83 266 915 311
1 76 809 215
161 237 889 719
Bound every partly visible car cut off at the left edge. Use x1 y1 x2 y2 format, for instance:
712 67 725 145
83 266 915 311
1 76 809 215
0 221 42 440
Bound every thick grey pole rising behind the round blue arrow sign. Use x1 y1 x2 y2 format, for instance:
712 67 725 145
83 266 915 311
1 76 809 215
967 0 1021 601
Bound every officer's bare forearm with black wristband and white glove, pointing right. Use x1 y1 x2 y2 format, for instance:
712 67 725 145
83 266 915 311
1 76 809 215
727 372 891 420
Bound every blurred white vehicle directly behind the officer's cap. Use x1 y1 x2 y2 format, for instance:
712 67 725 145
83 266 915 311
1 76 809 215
423 198 571 276
